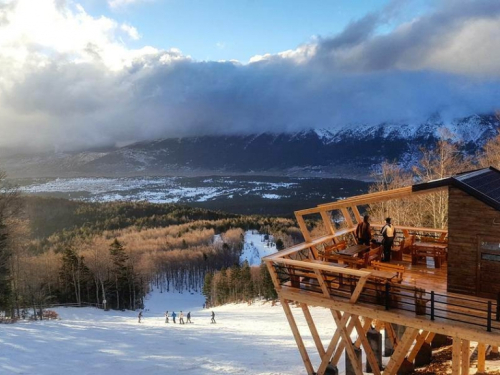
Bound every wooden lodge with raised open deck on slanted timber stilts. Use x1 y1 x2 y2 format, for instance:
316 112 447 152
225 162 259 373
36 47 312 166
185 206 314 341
264 167 500 375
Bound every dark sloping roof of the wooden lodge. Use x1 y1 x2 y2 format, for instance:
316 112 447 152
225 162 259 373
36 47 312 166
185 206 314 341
412 167 500 211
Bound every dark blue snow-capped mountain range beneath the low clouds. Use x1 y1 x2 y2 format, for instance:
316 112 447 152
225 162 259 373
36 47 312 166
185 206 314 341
0 115 500 178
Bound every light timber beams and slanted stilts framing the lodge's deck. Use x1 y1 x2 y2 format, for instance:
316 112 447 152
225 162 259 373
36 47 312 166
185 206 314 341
263 186 500 375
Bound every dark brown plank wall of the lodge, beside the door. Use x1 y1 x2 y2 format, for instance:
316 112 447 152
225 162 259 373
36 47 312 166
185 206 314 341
448 187 500 295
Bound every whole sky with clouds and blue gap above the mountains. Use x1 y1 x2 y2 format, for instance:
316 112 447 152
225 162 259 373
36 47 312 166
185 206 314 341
0 0 500 151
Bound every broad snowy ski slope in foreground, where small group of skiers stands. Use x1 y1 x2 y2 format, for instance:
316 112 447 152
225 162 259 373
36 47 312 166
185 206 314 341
0 291 343 375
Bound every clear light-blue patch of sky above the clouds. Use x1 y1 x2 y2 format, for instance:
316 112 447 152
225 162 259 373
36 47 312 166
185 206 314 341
82 0 429 62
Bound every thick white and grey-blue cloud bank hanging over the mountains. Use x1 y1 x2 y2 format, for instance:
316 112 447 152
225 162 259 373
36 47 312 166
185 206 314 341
0 0 500 151
